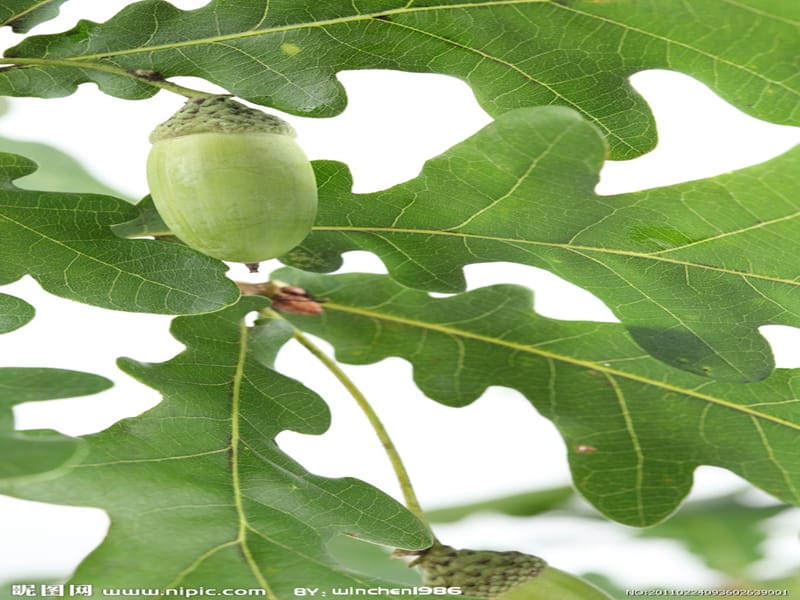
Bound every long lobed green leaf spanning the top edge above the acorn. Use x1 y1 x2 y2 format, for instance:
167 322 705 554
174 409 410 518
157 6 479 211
0 0 800 159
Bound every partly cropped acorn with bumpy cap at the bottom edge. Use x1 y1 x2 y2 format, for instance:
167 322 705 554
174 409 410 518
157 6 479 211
411 544 611 600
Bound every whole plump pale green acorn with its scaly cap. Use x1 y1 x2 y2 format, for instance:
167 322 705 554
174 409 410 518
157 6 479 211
147 96 317 265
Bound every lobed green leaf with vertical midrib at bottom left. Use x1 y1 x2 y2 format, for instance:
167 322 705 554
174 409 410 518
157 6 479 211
0 297 438 598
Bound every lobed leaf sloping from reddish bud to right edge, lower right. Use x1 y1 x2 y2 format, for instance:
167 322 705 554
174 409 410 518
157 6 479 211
274 269 800 526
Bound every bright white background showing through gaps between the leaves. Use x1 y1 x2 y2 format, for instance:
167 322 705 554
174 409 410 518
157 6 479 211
0 0 800 587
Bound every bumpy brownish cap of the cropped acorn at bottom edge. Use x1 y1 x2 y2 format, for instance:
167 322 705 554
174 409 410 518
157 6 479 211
411 544 547 598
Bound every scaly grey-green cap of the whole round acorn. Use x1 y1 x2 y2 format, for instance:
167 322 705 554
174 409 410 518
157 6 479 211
150 96 296 144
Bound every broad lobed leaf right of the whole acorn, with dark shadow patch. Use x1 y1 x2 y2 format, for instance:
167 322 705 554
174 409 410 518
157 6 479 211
285 107 800 381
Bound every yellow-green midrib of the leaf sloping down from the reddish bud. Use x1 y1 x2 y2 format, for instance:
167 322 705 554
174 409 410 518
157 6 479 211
325 302 800 431
